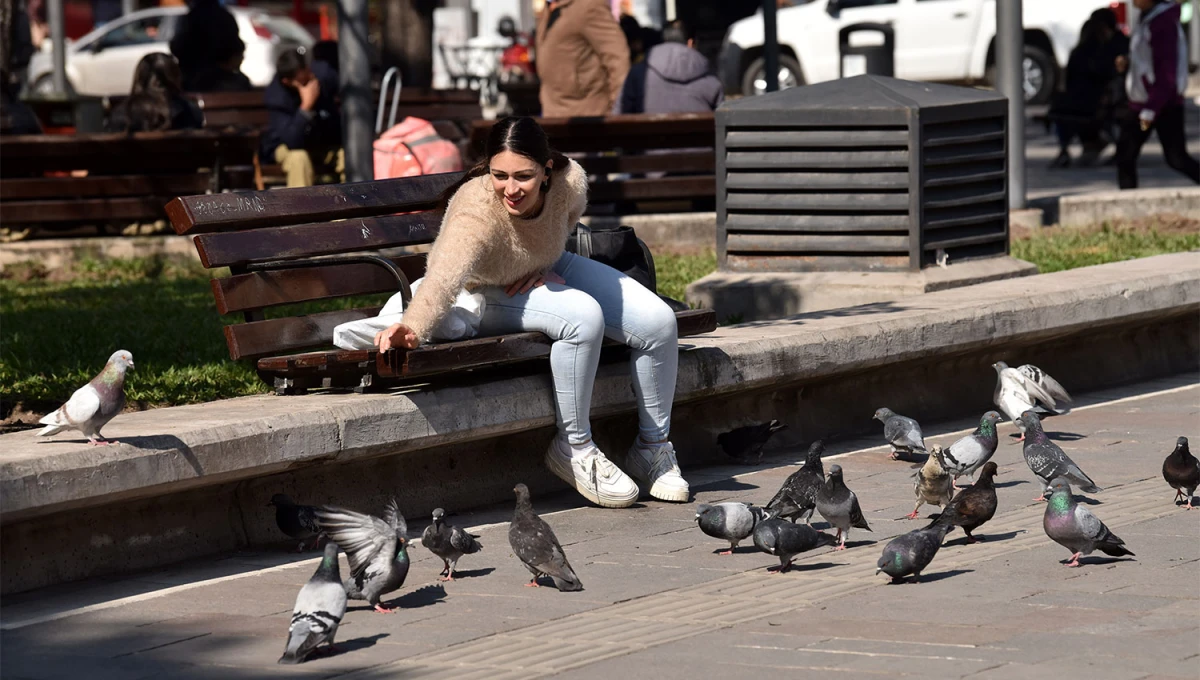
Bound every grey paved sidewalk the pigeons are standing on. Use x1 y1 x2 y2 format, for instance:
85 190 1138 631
0 375 1200 680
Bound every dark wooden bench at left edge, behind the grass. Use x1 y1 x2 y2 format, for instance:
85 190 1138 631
0 130 258 238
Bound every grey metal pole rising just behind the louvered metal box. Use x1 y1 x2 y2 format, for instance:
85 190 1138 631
996 0 1025 210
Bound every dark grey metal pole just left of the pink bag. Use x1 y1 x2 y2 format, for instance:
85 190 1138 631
337 0 374 182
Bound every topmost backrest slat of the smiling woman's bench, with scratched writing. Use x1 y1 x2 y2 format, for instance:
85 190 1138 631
167 173 462 235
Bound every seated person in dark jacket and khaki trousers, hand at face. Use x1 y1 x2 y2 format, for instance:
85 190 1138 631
263 48 346 187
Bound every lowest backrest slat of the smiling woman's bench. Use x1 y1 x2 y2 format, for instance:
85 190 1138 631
224 307 380 360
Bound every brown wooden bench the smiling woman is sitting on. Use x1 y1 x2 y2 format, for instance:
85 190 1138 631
167 173 716 395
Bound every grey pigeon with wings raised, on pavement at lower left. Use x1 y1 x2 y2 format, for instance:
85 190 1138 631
316 498 408 614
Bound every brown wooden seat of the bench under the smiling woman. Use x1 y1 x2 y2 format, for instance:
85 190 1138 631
258 309 716 378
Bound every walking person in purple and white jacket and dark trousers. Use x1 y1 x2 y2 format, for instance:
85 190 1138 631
1117 0 1200 188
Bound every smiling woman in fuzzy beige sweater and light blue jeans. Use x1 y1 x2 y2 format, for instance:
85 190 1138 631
376 118 689 507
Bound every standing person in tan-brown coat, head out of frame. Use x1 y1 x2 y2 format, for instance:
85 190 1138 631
535 0 629 118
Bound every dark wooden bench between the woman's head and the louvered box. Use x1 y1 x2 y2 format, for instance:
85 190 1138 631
472 114 716 215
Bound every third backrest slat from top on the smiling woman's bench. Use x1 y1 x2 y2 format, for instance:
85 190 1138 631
211 254 425 314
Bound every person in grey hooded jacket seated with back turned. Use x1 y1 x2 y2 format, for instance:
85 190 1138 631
613 22 725 114
